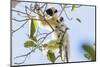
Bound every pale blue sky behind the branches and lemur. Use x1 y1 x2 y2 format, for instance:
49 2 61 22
12 2 95 65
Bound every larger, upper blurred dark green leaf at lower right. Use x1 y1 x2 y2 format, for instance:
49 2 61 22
83 44 96 60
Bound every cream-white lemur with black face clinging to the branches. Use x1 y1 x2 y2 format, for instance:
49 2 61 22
35 6 69 62
